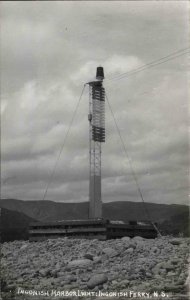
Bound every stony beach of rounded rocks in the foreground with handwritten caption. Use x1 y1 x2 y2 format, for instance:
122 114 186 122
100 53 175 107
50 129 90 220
1 237 190 300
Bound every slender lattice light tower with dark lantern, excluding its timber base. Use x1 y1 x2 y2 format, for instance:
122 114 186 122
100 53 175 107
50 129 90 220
88 67 105 219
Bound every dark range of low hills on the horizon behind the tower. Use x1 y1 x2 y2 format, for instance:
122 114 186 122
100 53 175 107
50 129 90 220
0 199 189 236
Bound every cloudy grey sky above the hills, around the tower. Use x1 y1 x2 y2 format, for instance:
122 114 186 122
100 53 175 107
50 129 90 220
0 1 189 204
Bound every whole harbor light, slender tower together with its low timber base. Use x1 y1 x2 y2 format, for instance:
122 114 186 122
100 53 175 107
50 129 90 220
29 67 157 242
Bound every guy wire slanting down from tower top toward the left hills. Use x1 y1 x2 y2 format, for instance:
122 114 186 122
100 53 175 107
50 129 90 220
43 84 86 200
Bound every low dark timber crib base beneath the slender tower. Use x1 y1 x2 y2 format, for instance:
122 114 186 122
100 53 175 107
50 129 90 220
29 219 157 242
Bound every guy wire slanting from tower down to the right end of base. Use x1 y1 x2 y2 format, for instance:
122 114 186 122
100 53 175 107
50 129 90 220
105 94 161 236
